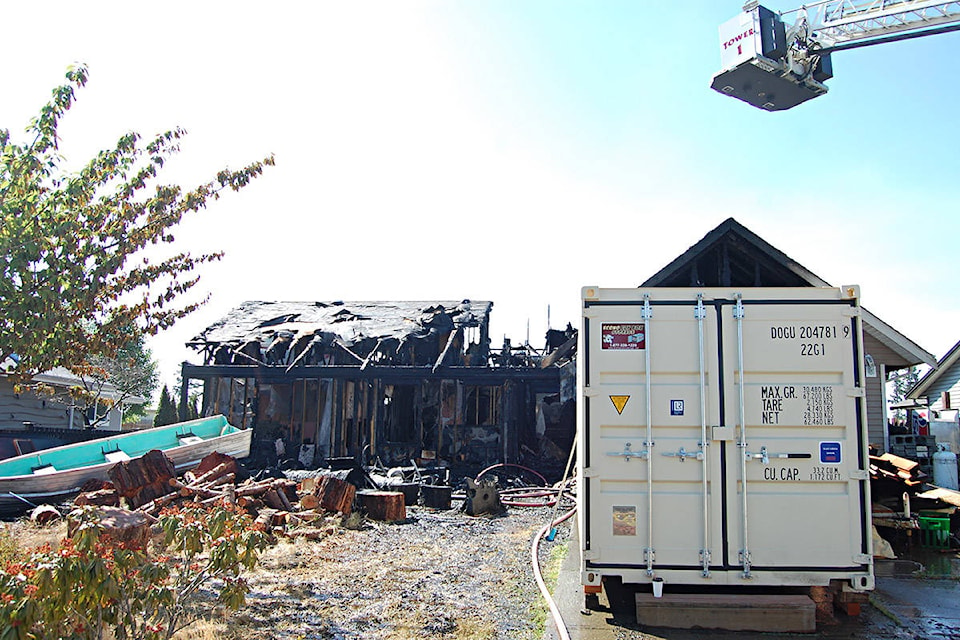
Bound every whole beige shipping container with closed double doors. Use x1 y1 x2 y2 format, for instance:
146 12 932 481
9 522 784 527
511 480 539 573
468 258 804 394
578 286 874 594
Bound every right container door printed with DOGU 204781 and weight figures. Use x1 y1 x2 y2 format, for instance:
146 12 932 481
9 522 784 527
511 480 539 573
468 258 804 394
721 298 867 578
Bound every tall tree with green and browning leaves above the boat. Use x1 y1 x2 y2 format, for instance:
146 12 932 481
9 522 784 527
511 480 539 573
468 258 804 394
0 66 273 379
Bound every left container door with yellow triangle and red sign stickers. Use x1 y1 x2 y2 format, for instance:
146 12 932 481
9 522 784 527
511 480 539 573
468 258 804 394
583 293 724 576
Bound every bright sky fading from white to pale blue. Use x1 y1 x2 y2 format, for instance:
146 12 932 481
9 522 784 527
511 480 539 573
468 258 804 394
0 0 960 396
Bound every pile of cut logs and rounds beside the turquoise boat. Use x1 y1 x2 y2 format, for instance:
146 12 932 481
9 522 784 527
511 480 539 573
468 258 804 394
74 451 406 538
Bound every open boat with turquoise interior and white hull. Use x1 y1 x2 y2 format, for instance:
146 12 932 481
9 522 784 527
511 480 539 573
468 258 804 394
0 415 253 517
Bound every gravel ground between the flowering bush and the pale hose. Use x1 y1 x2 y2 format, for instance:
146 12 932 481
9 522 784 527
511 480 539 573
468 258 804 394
226 507 569 640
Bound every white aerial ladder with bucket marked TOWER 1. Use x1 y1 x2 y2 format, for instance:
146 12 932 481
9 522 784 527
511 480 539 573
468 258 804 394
710 0 960 111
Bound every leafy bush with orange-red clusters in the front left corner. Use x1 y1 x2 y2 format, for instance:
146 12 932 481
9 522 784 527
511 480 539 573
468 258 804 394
0 505 267 640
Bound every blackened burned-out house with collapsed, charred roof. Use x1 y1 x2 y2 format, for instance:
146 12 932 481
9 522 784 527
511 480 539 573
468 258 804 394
181 300 576 466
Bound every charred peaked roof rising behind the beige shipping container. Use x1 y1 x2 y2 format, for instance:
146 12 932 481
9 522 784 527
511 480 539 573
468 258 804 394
640 218 936 367
